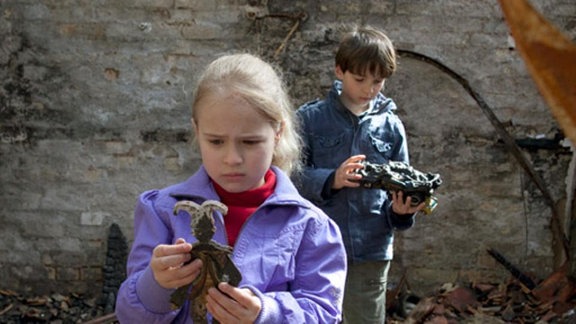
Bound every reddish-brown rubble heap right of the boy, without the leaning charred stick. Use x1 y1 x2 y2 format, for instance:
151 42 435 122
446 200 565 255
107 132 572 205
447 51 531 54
387 279 576 324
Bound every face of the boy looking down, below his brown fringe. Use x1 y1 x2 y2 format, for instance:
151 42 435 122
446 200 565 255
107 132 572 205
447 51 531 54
336 65 385 113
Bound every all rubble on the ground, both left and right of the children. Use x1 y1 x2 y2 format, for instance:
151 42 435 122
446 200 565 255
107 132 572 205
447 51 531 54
0 249 576 324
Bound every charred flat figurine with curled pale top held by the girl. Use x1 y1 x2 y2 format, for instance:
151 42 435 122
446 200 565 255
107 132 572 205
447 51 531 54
170 200 242 323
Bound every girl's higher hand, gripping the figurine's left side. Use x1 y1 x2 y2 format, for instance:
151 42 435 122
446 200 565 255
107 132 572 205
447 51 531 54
150 238 202 289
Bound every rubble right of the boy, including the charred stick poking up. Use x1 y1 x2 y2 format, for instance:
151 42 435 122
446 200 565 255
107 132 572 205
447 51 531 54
387 249 576 324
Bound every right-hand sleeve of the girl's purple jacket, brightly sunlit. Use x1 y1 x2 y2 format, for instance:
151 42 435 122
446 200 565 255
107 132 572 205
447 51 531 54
252 211 346 323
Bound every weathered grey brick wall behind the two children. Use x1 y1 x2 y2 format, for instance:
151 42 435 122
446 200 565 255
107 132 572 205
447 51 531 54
0 0 576 294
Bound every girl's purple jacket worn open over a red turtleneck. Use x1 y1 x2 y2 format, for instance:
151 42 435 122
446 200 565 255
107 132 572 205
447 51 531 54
116 167 346 324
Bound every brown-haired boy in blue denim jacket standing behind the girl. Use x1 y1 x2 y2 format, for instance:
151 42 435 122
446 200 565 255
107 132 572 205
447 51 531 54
296 27 424 324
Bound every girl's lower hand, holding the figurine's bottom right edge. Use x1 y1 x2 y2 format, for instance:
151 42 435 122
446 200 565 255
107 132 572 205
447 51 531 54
206 282 262 324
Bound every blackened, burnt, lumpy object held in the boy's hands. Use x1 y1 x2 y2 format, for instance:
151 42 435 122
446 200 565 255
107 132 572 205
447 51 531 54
357 161 442 214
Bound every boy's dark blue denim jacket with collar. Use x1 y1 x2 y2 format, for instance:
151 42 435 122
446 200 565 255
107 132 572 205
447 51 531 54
295 81 414 262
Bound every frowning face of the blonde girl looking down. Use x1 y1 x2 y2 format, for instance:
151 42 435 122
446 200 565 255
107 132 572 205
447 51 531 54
192 95 280 192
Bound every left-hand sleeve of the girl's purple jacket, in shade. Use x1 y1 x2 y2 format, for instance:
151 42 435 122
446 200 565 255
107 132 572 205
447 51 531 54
115 191 187 323
